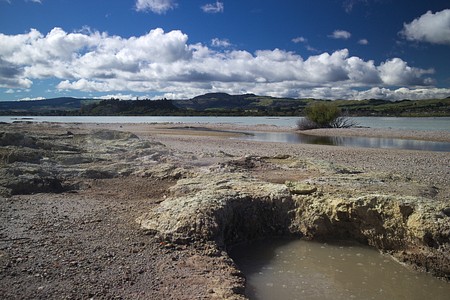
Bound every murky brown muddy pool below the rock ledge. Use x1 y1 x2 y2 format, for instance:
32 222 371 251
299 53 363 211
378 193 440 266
230 240 450 300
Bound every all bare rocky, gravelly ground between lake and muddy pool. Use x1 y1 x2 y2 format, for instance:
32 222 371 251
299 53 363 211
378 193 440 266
0 123 450 299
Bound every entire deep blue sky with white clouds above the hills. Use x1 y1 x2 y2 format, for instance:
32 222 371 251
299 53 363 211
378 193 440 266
0 0 450 101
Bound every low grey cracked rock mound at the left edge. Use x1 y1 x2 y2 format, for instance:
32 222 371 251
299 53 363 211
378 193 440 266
0 126 186 196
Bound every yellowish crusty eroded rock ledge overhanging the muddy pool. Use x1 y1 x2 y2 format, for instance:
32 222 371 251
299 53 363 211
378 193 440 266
138 172 450 279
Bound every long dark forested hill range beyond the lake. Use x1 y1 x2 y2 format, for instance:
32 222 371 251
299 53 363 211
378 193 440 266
0 93 450 116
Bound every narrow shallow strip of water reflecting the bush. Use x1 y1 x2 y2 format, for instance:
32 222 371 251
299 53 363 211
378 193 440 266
234 132 450 152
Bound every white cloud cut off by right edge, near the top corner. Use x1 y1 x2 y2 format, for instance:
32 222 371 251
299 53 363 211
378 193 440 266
400 9 450 45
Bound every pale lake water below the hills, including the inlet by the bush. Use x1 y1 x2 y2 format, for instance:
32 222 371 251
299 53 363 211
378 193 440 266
0 116 450 152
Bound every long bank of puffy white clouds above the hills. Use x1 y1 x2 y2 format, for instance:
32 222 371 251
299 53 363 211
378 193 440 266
0 28 444 98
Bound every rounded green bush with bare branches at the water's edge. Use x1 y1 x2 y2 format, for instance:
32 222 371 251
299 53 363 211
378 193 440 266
297 102 356 130
